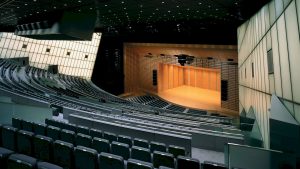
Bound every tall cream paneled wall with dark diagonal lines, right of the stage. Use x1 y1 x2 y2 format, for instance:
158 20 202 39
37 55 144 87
238 0 300 148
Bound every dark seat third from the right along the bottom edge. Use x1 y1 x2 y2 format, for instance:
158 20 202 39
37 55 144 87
153 151 175 168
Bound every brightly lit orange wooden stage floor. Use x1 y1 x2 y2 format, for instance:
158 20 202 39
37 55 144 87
157 86 236 115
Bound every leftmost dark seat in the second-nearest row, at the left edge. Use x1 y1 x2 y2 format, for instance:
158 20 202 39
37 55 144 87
2 126 18 151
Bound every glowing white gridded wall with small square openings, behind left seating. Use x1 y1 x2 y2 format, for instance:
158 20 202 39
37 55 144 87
0 32 101 79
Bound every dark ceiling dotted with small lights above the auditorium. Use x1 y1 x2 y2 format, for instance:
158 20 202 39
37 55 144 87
0 0 269 44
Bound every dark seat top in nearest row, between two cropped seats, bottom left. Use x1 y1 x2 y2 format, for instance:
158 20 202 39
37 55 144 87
7 154 37 169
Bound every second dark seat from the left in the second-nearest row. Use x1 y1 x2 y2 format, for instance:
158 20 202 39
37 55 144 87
17 130 34 156
